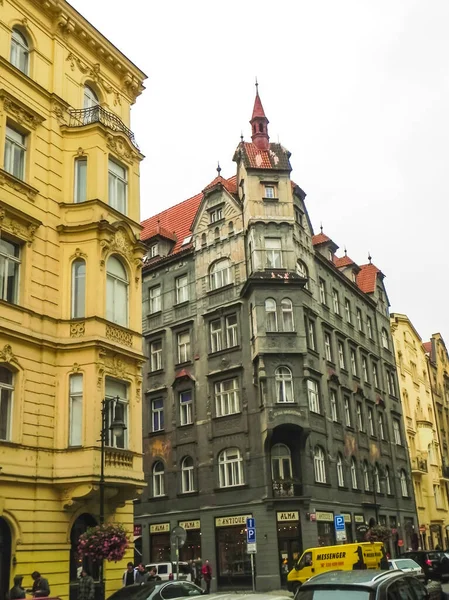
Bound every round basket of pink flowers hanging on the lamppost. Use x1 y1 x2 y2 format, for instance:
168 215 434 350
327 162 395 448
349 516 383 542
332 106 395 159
78 523 129 562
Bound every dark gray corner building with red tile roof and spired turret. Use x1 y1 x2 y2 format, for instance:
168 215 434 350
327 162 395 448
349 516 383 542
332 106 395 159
135 89 418 590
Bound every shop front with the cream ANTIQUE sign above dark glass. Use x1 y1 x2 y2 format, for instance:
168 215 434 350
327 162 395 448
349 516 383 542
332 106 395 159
214 514 252 589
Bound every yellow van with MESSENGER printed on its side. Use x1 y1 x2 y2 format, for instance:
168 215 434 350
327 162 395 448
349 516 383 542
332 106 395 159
287 542 388 592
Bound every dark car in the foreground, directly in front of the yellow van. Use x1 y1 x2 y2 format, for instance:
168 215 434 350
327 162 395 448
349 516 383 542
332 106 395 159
295 569 429 600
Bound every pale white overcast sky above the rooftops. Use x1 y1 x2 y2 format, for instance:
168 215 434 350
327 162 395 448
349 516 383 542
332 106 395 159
71 0 449 344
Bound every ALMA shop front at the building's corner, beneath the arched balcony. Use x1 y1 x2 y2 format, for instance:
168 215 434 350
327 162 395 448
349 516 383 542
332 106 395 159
276 511 302 586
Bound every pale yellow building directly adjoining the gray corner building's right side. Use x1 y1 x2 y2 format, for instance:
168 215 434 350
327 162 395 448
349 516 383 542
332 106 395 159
391 313 449 549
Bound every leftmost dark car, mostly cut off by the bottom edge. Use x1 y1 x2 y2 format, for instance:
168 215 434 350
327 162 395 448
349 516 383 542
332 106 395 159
108 581 204 600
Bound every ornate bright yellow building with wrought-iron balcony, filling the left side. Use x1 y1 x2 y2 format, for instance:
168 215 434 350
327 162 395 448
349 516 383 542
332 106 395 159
0 0 145 600
